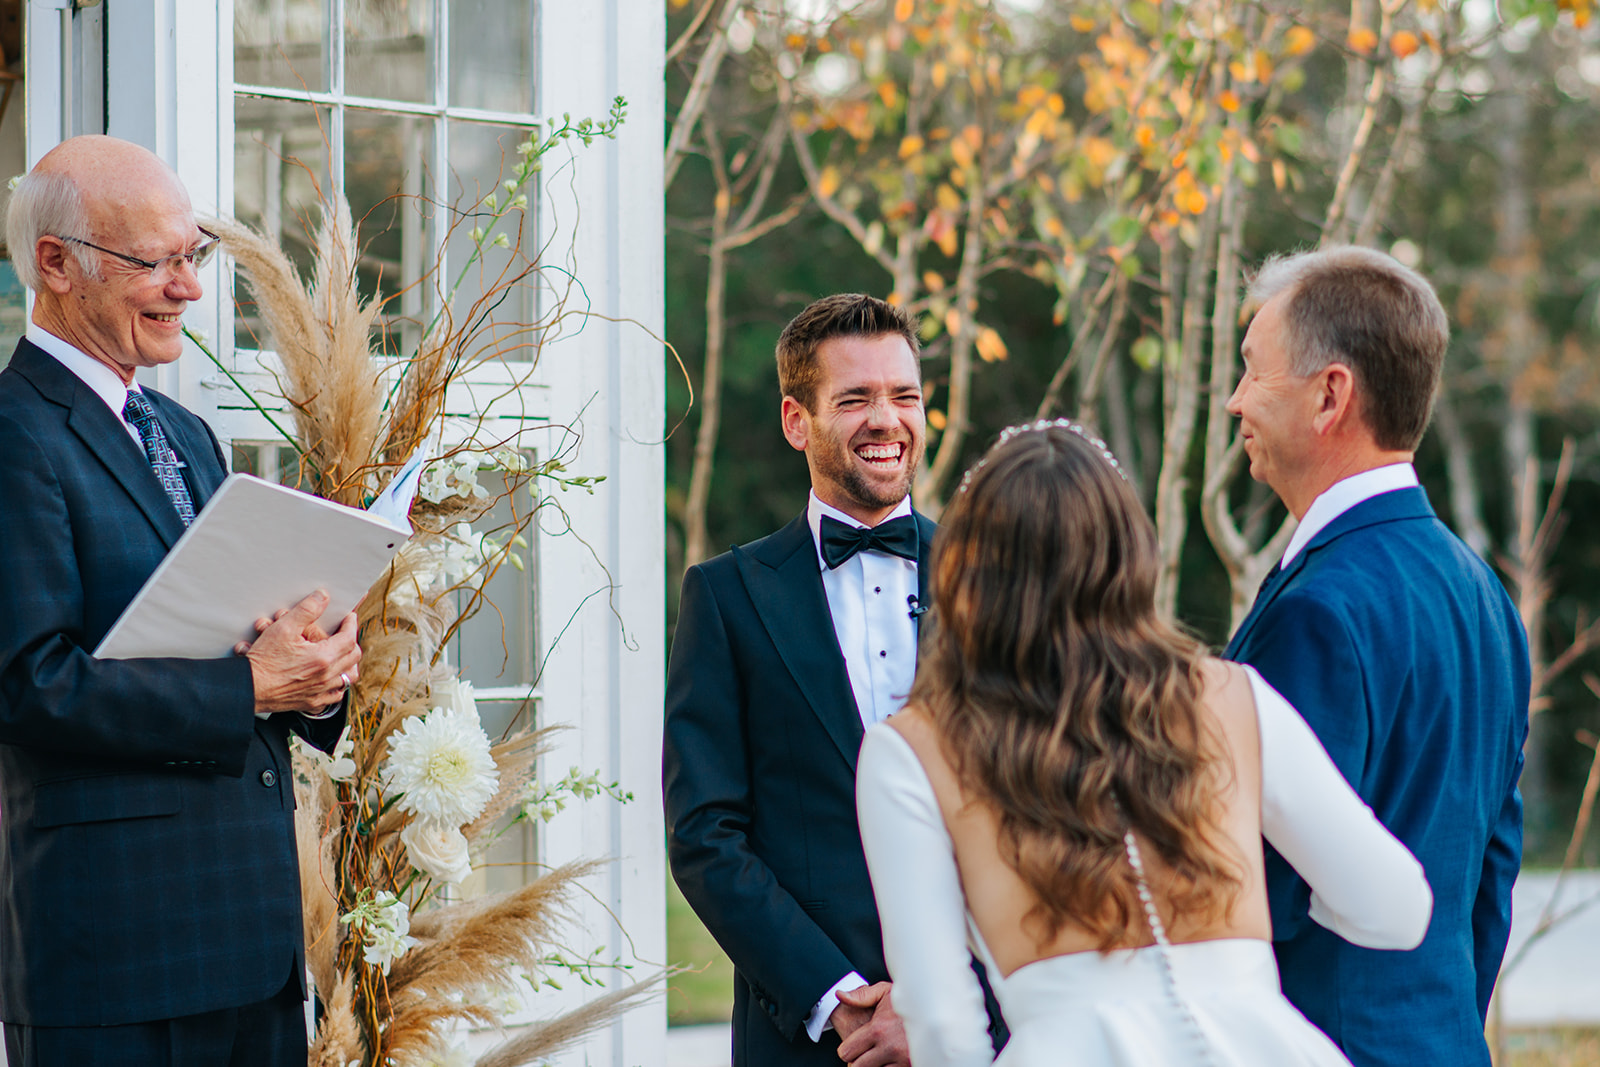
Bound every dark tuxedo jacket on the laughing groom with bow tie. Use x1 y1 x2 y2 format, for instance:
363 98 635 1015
662 514 934 1067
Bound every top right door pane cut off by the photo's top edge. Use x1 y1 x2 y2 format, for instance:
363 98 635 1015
450 0 538 114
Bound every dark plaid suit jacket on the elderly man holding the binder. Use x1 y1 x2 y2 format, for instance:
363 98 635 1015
0 341 342 1027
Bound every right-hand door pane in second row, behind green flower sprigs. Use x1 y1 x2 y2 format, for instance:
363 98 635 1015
450 122 538 360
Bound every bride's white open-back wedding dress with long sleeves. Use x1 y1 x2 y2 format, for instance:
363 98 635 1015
856 670 1432 1067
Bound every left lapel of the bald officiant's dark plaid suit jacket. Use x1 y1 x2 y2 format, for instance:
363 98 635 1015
11 338 184 549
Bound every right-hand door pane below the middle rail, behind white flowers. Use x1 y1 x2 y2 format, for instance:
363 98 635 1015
450 470 538 687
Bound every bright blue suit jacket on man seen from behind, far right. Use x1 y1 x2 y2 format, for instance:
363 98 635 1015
1226 488 1528 1067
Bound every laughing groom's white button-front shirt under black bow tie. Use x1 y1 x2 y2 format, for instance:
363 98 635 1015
806 493 917 726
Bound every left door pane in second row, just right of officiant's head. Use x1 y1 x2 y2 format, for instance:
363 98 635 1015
234 96 331 349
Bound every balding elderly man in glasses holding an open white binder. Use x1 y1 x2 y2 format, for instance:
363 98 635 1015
0 136 360 1067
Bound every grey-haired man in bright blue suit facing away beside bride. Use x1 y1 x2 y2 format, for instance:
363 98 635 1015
1226 248 1530 1067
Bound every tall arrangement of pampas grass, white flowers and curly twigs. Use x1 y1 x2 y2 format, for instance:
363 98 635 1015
190 99 658 1067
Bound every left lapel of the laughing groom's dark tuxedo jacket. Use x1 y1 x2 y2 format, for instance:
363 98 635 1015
733 514 864 773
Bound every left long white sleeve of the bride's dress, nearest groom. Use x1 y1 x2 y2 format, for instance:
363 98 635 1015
856 723 994 1067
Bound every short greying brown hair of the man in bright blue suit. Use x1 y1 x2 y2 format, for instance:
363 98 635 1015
1246 245 1450 451
